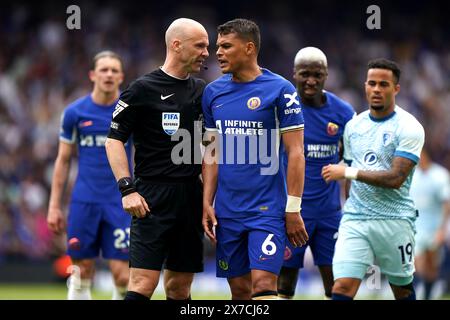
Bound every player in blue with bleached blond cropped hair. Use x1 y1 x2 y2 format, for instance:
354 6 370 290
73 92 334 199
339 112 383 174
278 47 355 299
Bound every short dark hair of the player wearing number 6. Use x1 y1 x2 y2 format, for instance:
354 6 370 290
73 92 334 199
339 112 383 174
217 19 261 53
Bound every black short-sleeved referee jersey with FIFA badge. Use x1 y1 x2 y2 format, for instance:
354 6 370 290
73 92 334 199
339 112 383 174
108 68 205 179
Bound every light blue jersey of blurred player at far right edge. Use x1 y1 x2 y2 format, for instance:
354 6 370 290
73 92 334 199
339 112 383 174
410 163 450 232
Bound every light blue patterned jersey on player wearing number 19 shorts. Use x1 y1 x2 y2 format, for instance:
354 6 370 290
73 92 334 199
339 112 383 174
343 106 425 220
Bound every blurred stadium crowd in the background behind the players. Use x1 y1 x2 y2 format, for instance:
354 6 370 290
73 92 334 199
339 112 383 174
0 0 450 288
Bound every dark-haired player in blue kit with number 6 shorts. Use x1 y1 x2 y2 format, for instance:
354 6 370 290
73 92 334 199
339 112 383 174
202 19 308 300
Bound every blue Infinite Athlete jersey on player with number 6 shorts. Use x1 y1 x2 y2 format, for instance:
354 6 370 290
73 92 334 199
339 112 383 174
202 69 303 218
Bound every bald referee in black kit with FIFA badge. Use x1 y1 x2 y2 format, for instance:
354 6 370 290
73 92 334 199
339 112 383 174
106 18 209 300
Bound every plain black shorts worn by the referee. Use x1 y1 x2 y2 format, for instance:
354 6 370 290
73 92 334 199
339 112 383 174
130 178 204 273
